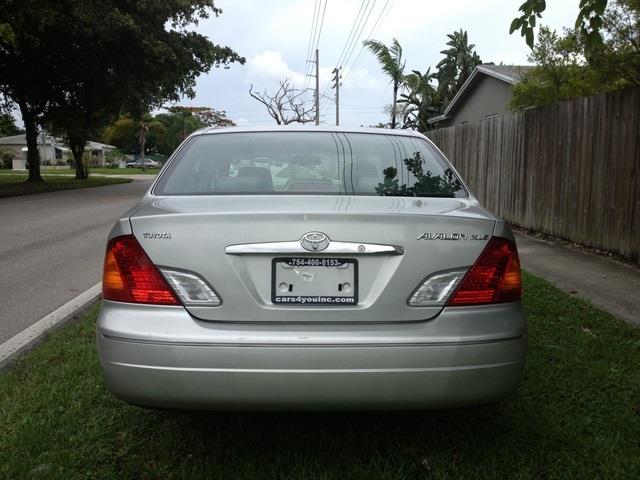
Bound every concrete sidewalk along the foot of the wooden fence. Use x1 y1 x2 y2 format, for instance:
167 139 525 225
514 231 640 326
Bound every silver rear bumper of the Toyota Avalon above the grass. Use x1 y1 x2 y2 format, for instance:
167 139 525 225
98 302 526 410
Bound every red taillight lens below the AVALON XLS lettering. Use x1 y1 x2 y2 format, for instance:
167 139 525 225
449 237 522 306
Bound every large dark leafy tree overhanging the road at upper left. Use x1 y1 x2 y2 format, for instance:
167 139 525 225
0 0 244 180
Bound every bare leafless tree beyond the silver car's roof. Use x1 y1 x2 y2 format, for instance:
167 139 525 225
249 79 315 125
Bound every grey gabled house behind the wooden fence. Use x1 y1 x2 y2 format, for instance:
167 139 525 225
429 64 533 128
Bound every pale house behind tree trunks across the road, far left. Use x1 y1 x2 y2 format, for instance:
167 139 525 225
0 134 116 170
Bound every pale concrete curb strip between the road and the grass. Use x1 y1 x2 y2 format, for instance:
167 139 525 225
0 282 102 371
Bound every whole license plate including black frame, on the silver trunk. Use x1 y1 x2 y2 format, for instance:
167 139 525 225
271 257 358 305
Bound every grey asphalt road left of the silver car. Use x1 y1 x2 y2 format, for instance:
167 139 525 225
0 176 153 344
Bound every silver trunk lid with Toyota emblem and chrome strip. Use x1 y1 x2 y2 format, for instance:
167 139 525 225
131 195 495 322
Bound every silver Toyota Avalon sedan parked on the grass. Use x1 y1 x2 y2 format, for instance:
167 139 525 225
97 127 526 410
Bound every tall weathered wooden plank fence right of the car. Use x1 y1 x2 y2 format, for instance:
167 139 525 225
427 88 640 259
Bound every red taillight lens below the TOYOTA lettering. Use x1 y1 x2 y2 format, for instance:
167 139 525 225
102 235 180 305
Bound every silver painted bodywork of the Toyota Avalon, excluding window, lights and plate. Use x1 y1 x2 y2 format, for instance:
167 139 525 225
98 127 526 409
